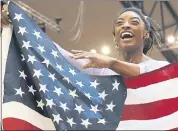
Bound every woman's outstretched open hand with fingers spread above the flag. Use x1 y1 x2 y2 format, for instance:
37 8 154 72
70 50 115 69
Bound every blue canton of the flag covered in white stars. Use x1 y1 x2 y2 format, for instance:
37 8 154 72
4 3 126 130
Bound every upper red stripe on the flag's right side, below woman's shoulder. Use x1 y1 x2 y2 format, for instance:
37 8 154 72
124 62 178 89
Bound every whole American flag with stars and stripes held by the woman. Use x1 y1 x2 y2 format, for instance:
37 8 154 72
2 2 178 130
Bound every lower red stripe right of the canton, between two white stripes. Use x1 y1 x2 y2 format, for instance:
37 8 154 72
122 97 178 120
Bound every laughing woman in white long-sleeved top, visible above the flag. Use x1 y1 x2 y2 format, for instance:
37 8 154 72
2 2 169 77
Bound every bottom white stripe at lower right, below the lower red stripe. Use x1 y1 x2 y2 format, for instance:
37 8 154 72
117 110 178 130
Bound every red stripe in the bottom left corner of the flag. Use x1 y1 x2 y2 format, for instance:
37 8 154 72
3 118 41 130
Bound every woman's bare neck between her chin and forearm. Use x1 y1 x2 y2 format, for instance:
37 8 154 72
118 50 143 64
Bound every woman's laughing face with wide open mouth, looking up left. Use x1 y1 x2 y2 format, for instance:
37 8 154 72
115 11 146 51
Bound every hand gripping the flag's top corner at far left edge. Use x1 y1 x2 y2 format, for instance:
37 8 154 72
1 5 10 28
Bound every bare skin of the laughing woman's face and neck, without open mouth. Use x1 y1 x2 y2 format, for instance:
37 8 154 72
114 11 148 64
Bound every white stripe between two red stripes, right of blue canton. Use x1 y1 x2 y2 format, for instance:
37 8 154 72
125 78 178 105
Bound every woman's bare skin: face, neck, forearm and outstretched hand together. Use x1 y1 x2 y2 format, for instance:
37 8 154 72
70 11 150 77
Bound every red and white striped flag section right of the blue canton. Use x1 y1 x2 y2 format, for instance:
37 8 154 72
117 62 178 130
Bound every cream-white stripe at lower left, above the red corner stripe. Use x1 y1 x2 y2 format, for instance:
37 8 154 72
2 102 55 130
